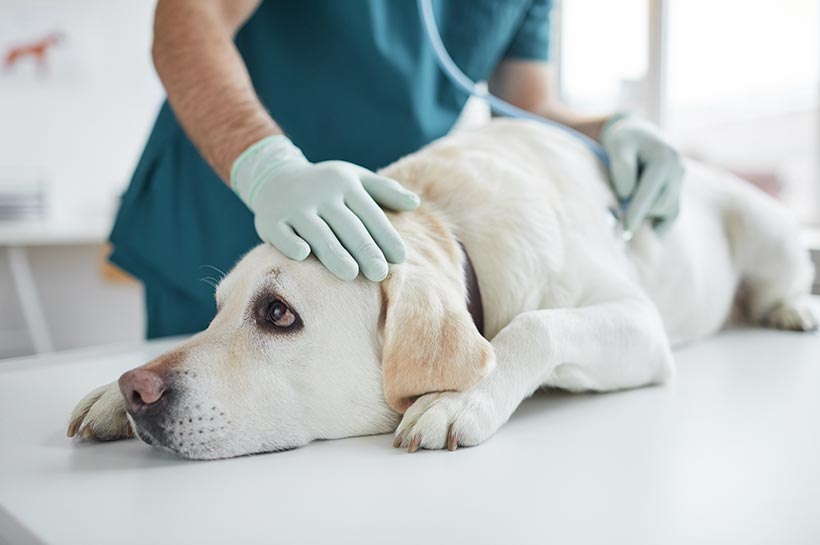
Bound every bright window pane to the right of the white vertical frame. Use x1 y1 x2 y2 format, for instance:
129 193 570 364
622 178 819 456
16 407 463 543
667 0 820 223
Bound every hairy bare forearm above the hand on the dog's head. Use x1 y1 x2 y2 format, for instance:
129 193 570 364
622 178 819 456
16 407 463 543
152 0 282 182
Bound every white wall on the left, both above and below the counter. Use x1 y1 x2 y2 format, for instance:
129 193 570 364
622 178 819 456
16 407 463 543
0 0 163 357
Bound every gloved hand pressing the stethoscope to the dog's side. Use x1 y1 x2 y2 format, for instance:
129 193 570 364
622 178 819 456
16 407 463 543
601 114 684 233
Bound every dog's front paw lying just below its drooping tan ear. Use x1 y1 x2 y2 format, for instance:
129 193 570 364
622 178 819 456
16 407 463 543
393 391 502 452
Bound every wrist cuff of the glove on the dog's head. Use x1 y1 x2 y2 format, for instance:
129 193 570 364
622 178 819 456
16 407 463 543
231 134 309 210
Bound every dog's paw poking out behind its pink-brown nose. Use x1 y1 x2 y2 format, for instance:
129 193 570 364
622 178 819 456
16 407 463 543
66 382 134 441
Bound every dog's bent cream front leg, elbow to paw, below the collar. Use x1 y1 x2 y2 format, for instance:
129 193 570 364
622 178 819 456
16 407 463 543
394 298 673 451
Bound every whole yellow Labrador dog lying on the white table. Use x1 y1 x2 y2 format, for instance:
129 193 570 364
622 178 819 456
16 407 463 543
68 120 817 459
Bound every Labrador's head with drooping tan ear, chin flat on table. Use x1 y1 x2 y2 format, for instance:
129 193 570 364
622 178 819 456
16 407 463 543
120 240 494 459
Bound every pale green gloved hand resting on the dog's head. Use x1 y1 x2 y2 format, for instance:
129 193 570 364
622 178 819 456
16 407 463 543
231 135 419 281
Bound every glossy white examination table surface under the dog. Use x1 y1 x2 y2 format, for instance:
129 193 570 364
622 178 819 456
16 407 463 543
0 330 820 545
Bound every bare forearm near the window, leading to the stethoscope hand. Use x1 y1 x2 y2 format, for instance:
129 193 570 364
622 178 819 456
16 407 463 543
489 59 607 140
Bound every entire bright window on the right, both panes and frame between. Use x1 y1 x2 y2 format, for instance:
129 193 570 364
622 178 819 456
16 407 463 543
554 0 820 225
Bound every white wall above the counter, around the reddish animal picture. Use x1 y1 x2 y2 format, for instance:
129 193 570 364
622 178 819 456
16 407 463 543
0 0 163 221
